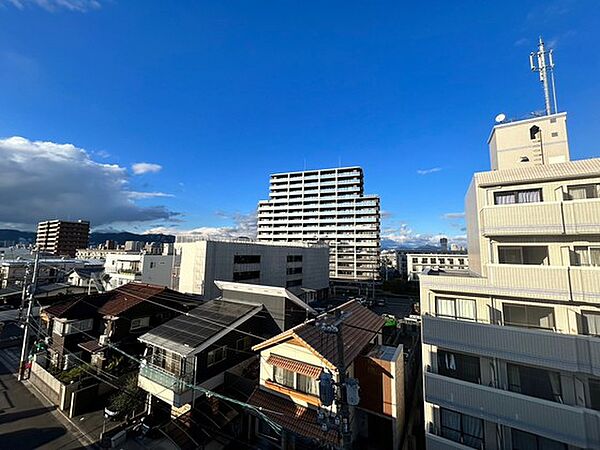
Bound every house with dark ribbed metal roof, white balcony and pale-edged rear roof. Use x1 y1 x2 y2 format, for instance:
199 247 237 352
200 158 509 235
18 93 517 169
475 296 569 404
138 282 314 417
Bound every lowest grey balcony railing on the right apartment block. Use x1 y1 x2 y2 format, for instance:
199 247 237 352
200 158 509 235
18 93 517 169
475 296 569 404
425 373 600 448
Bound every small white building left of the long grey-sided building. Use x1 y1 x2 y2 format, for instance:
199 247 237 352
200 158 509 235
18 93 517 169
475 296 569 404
104 252 174 290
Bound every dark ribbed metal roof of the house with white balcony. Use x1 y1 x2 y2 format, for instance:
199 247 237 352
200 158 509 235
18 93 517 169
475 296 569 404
139 300 263 357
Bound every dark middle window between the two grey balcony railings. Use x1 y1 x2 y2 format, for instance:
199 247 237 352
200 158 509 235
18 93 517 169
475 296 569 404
506 363 562 403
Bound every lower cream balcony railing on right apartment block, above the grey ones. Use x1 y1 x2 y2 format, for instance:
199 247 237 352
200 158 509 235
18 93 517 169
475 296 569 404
421 264 600 303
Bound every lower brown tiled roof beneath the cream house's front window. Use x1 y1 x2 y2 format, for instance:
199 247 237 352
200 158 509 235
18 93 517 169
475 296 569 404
248 388 339 445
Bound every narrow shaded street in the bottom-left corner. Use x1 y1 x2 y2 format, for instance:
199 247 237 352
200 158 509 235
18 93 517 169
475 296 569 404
0 346 85 450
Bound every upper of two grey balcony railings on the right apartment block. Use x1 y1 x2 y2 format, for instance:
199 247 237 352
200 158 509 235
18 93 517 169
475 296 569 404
423 315 600 376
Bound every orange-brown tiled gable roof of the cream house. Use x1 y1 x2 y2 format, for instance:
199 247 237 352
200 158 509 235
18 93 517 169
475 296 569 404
253 300 385 366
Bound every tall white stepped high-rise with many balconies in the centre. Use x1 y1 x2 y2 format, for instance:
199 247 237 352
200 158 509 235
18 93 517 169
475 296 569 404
258 167 380 282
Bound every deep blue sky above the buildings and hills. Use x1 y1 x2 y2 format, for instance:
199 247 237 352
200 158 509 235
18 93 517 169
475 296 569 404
0 0 600 246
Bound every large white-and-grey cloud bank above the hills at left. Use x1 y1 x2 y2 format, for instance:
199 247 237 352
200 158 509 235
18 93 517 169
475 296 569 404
0 137 178 228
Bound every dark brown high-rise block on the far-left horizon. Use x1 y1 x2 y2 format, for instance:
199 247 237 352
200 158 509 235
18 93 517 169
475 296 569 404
35 220 90 258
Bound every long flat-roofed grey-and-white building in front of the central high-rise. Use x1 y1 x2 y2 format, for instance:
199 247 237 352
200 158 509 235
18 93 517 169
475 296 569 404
174 235 329 302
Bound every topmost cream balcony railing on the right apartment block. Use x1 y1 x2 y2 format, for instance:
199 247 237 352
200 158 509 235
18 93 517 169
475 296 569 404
480 199 600 237
